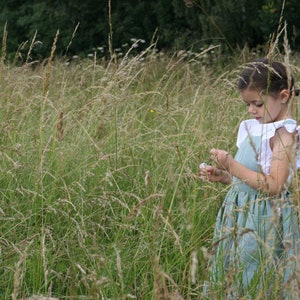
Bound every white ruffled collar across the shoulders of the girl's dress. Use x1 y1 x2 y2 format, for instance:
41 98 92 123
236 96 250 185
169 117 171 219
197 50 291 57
237 119 300 147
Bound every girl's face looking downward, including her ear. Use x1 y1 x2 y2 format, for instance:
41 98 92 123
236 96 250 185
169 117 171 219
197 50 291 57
241 89 289 124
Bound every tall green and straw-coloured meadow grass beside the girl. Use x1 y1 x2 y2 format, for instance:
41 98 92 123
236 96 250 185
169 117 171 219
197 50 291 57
0 43 297 299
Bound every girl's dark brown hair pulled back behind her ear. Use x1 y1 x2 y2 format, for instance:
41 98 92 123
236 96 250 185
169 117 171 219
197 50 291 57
238 58 299 96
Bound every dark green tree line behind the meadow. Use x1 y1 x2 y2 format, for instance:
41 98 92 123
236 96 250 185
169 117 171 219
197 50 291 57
0 0 300 58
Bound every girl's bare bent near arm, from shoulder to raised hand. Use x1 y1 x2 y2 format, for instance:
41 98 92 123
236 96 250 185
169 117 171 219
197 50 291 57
210 128 294 195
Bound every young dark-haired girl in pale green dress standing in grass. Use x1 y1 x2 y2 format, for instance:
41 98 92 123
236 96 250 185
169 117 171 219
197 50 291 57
200 59 300 299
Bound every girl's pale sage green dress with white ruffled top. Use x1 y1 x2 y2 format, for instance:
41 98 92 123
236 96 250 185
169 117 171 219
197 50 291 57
209 119 300 299
